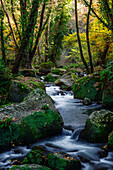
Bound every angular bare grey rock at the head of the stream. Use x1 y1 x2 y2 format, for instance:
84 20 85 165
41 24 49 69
54 72 73 90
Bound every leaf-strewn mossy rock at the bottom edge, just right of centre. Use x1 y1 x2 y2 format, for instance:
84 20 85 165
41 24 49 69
47 152 81 170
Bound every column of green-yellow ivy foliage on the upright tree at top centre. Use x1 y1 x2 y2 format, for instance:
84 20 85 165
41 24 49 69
48 0 70 63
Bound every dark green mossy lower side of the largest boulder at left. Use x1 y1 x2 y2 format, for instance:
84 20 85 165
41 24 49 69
0 109 63 148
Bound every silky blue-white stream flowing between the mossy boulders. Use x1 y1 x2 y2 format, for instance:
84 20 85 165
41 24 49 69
0 84 113 170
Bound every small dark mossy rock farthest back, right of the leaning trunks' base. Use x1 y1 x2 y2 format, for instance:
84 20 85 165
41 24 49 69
39 61 54 75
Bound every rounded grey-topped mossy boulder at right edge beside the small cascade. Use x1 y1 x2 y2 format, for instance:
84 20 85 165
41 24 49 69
80 109 113 142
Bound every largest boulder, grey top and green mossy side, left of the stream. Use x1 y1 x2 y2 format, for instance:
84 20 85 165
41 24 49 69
0 89 63 148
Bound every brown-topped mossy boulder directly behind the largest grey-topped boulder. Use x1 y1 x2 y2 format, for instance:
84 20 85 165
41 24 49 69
8 77 45 103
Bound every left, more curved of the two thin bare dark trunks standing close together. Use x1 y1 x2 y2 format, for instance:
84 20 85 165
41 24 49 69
75 0 90 74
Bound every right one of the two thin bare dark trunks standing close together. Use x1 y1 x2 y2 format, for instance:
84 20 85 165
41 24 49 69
86 0 93 73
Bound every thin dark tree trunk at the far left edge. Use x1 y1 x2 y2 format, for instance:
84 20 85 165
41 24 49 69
0 9 6 66
